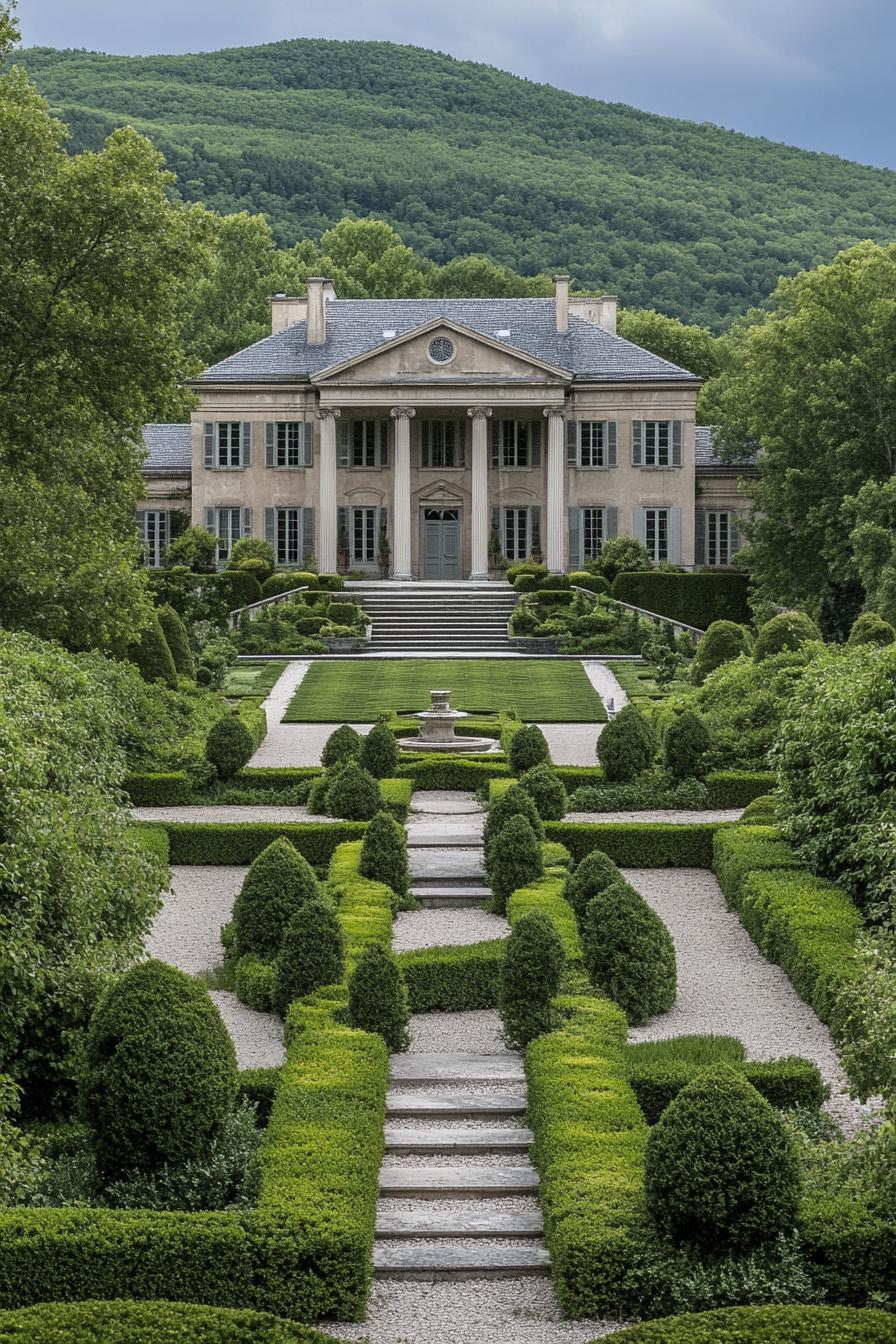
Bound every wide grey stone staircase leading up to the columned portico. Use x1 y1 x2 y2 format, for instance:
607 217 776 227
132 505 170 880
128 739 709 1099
347 582 516 655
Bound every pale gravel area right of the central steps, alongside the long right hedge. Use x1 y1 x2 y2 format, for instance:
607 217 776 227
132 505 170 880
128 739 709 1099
623 868 873 1133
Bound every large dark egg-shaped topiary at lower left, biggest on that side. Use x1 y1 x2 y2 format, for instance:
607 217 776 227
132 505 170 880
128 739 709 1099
81 961 238 1177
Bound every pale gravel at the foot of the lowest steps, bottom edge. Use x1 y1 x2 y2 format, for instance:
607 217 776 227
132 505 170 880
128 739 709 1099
321 1279 621 1344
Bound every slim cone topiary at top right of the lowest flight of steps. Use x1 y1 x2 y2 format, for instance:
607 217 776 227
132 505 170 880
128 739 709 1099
501 911 566 1050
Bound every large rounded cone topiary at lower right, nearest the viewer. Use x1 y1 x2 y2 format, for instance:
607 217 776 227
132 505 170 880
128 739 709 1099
646 1064 799 1250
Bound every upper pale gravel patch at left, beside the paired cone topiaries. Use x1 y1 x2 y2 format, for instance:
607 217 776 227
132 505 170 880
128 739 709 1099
145 866 249 976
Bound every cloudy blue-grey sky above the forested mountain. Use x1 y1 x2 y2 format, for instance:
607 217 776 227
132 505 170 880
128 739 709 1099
19 0 896 168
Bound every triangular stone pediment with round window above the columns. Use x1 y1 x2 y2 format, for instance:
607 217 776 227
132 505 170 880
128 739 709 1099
312 317 571 384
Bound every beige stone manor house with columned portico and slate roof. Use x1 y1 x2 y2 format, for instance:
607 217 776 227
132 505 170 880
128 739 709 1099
138 276 746 579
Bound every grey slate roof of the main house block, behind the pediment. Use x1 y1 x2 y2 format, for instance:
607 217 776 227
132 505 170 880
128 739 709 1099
200 298 696 383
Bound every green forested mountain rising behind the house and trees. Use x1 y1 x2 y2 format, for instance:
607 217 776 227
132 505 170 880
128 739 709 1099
17 40 896 328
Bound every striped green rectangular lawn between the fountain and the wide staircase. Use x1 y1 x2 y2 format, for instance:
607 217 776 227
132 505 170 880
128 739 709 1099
283 659 607 723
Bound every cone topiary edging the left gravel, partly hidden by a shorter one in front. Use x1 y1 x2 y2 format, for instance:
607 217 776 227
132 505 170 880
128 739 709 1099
234 836 320 961
